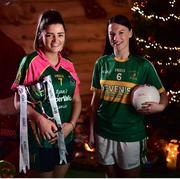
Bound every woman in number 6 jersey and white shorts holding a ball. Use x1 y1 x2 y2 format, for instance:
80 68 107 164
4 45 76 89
89 15 168 178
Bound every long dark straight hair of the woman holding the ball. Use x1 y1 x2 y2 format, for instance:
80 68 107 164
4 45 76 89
103 14 139 55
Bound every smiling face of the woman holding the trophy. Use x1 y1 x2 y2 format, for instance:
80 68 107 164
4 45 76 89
41 24 65 53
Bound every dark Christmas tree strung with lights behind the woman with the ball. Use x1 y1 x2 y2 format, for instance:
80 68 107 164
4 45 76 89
131 0 180 171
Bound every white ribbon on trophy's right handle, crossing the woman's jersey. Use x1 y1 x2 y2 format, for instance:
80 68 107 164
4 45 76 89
44 76 67 164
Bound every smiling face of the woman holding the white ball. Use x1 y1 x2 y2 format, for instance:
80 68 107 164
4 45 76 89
108 23 132 52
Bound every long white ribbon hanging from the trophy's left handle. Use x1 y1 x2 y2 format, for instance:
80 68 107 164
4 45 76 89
18 85 30 173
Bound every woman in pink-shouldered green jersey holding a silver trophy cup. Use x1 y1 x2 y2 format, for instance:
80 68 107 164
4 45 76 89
12 10 81 178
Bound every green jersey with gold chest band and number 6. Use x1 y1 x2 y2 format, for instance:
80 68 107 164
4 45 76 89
91 55 165 142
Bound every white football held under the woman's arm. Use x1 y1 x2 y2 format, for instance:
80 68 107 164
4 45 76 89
131 85 160 110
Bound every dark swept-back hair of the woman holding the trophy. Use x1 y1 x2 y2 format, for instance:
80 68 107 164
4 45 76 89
34 9 65 50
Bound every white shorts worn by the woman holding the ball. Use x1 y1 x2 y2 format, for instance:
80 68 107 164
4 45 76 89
96 135 147 169
